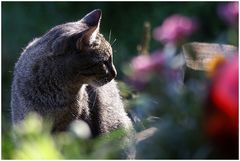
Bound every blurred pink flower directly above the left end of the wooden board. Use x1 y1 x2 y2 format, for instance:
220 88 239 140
153 14 197 43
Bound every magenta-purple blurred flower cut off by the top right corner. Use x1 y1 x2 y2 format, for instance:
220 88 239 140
218 2 238 26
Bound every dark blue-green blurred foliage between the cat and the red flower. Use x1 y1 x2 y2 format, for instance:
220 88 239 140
129 69 211 159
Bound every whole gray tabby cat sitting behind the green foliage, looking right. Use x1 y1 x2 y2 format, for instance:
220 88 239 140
11 10 133 158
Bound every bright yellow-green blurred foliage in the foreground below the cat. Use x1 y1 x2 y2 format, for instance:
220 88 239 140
3 113 128 159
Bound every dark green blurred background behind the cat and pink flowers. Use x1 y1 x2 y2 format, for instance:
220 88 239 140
2 2 238 158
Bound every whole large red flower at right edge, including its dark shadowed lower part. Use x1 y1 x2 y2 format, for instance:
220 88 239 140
204 56 238 158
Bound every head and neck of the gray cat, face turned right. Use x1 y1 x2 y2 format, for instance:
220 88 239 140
36 9 117 86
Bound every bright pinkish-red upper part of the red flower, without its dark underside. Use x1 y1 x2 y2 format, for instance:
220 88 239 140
211 57 238 120
